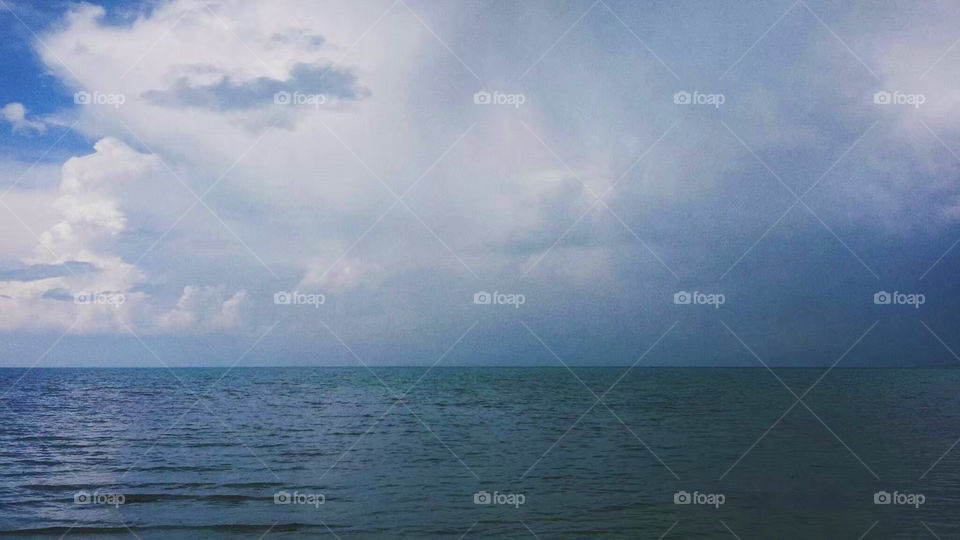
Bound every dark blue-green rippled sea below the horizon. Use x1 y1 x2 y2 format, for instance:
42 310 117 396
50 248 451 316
0 367 960 539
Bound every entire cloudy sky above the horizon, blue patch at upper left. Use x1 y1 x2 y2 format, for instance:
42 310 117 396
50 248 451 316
0 0 960 367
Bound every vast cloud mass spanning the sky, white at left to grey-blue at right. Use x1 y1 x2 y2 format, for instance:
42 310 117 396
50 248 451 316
0 0 960 368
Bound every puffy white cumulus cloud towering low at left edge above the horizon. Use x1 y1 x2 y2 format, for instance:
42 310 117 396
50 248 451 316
0 138 246 333
